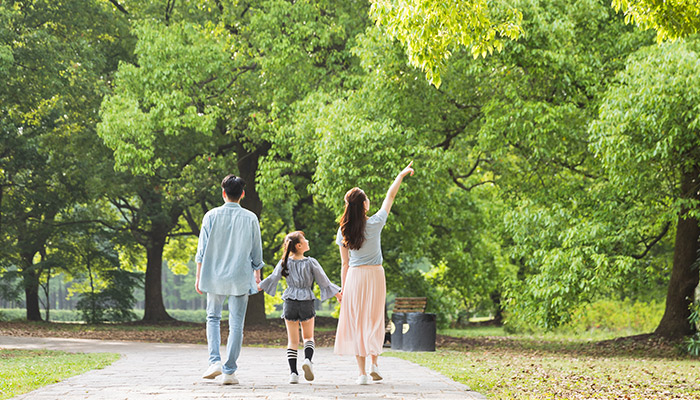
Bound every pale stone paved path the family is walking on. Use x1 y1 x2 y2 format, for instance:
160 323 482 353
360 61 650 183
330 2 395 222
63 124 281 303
0 336 485 400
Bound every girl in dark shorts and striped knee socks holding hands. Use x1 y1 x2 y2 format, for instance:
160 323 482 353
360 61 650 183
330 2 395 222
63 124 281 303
259 231 341 383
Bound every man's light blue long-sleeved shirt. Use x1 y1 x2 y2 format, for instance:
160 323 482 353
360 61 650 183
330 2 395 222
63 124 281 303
195 202 265 296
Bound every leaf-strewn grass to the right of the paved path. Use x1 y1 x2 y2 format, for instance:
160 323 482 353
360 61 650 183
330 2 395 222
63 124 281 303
385 338 700 399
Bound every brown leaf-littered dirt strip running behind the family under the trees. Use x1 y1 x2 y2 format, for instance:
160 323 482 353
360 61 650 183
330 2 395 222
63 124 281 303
0 317 679 358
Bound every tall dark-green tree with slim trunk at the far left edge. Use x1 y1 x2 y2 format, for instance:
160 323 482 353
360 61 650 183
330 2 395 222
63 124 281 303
0 1 130 320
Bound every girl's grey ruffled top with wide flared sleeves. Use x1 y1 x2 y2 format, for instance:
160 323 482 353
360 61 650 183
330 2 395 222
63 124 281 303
260 257 340 301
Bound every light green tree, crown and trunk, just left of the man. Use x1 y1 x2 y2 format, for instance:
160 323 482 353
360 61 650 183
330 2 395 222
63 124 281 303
98 21 253 321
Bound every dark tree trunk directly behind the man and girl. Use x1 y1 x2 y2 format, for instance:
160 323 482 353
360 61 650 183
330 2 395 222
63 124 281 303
238 144 268 325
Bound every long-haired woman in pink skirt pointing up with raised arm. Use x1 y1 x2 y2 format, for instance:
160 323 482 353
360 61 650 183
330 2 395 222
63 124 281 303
334 161 414 385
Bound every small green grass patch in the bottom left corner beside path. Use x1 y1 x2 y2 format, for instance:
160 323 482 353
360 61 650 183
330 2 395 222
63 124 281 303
0 349 119 400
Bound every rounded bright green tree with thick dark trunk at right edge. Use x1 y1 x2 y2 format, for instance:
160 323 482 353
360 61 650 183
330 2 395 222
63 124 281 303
592 40 700 338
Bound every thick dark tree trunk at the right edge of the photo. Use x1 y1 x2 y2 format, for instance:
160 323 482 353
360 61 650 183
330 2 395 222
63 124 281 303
654 169 700 339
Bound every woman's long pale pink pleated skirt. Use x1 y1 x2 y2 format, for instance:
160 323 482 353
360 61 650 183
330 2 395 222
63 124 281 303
333 265 386 357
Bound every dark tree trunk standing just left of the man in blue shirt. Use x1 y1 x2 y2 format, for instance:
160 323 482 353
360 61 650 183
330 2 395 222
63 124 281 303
143 231 173 322
